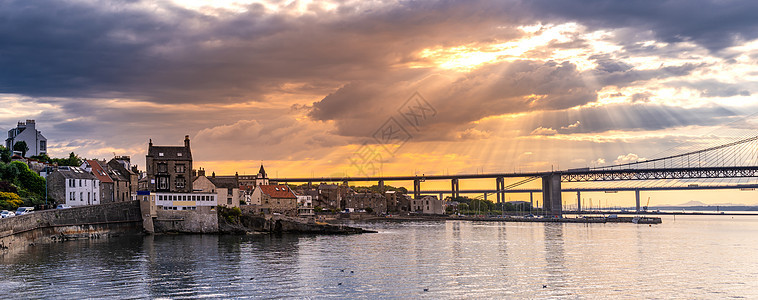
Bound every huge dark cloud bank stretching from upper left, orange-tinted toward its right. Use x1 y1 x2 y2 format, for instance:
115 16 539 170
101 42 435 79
0 1 519 103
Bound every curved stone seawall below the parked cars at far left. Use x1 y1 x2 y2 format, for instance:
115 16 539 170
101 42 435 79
0 201 142 254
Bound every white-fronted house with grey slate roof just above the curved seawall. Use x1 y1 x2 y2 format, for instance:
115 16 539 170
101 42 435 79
47 167 101 206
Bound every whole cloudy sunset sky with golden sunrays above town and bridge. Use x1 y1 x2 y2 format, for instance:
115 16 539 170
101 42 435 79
0 0 758 202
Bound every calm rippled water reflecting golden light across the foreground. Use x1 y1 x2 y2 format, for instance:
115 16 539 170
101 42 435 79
0 216 758 299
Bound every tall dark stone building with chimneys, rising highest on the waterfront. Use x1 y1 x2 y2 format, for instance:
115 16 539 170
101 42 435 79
145 135 192 193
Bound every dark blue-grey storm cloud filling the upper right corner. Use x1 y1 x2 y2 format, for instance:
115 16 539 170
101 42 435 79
525 0 758 51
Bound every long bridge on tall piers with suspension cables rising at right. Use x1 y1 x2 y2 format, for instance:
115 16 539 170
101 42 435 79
271 136 758 216
